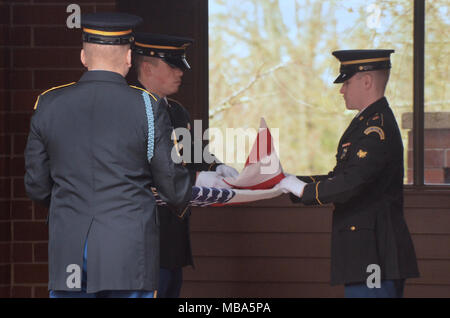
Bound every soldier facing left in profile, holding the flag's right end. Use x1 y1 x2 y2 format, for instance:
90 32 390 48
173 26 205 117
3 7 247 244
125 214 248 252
280 50 419 297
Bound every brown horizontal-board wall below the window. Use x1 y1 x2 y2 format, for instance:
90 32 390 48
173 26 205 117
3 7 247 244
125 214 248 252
181 191 450 298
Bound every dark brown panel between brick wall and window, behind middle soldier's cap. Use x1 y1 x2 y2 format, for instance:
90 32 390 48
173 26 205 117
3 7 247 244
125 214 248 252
117 0 208 129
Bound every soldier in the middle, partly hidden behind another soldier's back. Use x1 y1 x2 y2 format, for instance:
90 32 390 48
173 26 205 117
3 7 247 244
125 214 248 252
133 33 238 298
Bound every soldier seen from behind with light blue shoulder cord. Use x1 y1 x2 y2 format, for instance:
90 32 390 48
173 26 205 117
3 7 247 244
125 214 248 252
25 13 192 297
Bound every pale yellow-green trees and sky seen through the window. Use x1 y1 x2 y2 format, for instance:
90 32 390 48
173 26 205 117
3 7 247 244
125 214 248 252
209 0 449 174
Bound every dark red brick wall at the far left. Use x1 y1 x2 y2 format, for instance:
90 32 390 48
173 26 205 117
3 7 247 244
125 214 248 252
0 0 115 297
